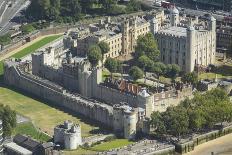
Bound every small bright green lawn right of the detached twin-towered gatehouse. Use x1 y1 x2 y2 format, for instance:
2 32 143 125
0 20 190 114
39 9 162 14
90 139 133 151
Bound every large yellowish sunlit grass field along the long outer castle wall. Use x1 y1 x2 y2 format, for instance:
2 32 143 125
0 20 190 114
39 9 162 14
0 87 97 137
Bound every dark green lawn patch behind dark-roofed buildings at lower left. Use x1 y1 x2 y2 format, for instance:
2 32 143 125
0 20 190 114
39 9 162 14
14 122 52 142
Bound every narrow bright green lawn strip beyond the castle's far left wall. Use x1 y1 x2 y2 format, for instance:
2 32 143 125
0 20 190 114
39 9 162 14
0 35 61 75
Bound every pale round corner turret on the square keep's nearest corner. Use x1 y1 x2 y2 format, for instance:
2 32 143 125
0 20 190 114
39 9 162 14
184 25 197 72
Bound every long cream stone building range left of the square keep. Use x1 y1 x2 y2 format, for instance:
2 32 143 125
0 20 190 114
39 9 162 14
64 11 165 58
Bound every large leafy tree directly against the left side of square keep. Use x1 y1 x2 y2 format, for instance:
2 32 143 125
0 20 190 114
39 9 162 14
135 33 160 61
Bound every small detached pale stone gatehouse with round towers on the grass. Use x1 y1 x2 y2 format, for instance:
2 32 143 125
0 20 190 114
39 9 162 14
54 121 82 150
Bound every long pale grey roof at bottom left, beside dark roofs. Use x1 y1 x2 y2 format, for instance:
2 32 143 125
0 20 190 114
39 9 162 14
4 142 32 155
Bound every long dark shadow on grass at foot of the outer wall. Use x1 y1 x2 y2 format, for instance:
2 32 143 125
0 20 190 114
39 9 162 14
0 78 111 134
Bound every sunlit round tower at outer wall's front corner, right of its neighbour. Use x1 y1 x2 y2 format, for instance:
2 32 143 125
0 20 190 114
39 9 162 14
123 109 137 139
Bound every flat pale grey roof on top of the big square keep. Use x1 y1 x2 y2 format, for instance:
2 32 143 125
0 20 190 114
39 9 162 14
158 26 187 37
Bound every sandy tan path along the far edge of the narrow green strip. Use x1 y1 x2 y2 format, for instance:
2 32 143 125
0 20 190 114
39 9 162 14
0 33 63 61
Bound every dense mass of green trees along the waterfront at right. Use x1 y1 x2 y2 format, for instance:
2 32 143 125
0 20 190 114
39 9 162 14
151 88 232 137
